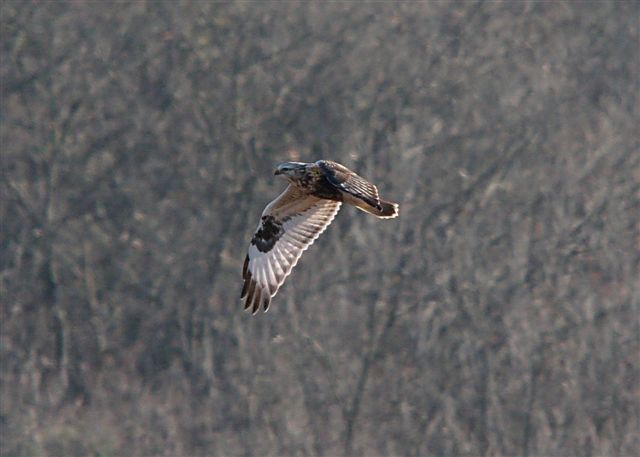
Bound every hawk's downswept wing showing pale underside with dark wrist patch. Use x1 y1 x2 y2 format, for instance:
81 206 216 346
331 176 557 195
241 185 341 314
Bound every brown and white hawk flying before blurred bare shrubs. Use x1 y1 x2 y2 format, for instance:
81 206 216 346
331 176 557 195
241 160 398 314
